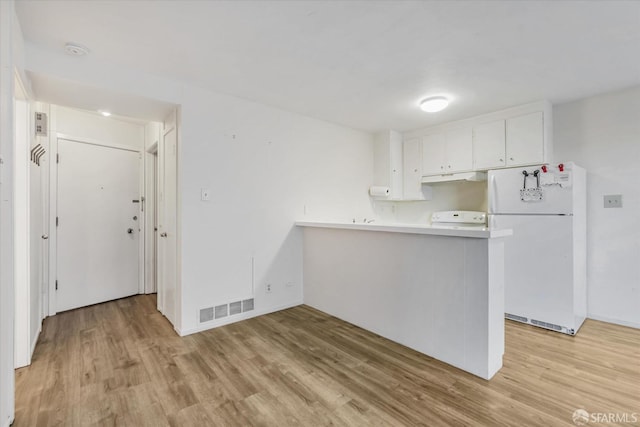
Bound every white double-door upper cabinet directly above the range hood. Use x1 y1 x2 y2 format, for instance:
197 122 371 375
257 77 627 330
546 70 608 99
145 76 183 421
422 128 473 176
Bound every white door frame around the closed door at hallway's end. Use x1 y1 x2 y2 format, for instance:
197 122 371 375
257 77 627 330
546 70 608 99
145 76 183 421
48 135 146 316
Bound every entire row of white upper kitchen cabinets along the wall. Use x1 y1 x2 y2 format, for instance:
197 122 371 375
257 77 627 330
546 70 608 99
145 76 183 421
396 101 553 186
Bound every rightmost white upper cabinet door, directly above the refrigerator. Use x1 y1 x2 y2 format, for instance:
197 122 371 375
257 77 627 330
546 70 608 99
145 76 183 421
506 111 544 166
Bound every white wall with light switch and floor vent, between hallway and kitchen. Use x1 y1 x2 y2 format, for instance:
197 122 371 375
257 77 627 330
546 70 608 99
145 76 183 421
27 45 373 333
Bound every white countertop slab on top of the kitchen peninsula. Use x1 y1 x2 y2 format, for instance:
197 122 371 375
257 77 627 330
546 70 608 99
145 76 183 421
295 221 513 239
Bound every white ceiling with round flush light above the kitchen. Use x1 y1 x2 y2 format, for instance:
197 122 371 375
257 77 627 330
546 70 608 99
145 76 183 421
16 0 640 131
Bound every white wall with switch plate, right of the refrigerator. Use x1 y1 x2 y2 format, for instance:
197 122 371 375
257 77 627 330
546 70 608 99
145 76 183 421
553 86 640 327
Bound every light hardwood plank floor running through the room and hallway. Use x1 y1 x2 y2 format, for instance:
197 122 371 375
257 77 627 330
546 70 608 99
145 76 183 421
14 296 640 427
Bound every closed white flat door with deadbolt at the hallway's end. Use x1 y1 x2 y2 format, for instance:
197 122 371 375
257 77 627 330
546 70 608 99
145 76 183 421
56 139 140 311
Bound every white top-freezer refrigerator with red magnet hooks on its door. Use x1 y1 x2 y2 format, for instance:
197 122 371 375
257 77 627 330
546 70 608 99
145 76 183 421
488 162 587 335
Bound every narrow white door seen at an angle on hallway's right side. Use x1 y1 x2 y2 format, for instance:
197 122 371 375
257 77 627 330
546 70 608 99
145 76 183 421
158 125 178 325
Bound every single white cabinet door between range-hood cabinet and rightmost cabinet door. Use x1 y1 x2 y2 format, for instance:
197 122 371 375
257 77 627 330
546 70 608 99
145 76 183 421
473 120 506 170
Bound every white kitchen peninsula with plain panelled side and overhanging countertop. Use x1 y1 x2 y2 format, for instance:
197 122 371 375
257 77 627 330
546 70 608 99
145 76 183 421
296 221 511 379
